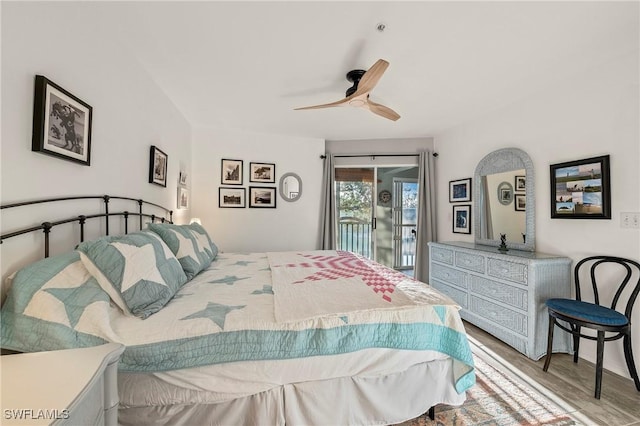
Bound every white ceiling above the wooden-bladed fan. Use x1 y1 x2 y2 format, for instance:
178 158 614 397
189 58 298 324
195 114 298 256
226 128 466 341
104 1 638 140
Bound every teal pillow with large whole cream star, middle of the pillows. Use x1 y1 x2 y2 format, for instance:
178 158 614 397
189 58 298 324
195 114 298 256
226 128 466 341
77 231 187 319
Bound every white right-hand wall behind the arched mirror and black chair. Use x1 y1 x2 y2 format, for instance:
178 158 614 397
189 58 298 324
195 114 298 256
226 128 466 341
435 48 640 377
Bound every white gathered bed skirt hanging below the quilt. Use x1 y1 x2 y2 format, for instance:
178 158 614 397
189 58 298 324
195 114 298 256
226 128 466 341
118 358 466 426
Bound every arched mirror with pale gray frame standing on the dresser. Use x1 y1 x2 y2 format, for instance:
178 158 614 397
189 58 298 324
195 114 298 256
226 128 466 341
473 148 535 251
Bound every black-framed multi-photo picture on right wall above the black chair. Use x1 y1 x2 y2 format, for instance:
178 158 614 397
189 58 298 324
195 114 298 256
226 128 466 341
550 155 611 219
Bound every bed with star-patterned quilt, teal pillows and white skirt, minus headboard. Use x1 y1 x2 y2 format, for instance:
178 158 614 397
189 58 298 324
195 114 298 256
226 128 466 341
0 195 475 425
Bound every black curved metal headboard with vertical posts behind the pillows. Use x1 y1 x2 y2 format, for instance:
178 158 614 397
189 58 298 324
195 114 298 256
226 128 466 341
0 195 173 257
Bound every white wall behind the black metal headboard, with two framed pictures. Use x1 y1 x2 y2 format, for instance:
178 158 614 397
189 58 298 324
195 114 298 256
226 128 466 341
0 2 191 282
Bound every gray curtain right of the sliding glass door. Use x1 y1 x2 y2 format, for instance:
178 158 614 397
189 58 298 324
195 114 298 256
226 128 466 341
414 151 436 283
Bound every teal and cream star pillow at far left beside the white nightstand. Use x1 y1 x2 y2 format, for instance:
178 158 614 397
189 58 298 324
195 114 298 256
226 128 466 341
0 251 110 352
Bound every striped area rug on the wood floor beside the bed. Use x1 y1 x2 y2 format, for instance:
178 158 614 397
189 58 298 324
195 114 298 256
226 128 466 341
401 342 593 426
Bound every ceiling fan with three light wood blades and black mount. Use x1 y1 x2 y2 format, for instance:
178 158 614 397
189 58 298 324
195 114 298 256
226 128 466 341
295 59 400 121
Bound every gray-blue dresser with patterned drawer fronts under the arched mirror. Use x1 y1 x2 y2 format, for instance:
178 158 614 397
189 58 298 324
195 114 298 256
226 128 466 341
429 242 572 360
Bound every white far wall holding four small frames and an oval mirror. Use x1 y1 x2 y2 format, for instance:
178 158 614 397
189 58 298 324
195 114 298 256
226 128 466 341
191 128 324 252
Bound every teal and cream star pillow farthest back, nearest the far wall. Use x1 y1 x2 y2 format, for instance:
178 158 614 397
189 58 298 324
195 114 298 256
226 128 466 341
149 223 218 280
